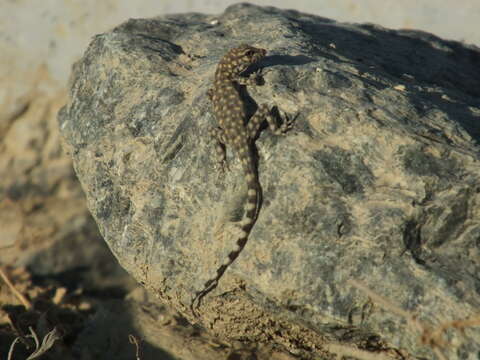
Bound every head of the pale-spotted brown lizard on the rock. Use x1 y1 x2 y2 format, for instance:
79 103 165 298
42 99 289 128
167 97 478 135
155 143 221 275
220 44 267 76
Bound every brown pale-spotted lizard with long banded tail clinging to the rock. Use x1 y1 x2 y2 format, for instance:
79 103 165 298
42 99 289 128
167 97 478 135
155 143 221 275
190 44 295 314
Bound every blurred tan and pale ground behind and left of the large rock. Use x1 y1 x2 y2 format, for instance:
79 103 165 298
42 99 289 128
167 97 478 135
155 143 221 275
0 0 480 359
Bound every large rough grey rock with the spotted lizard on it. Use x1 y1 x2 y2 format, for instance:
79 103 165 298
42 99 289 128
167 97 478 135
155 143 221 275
59 4 480 359
